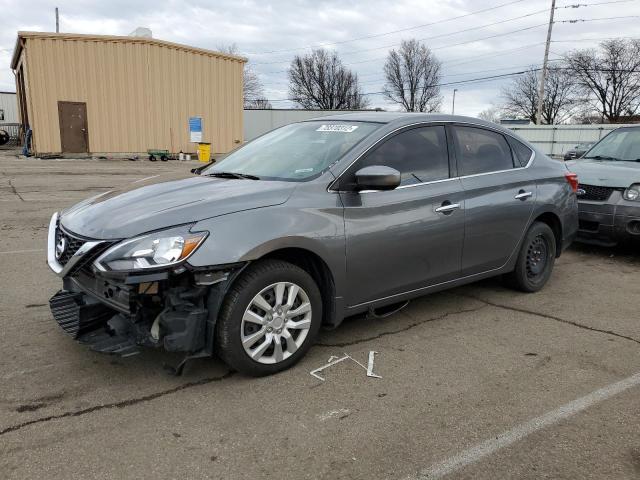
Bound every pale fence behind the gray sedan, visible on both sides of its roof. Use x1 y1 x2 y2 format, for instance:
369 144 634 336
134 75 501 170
244 110 636 157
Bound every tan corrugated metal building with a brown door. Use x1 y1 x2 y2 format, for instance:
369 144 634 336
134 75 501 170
11 32 246 154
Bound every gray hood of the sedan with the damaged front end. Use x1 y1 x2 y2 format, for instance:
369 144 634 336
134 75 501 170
60 174 296 240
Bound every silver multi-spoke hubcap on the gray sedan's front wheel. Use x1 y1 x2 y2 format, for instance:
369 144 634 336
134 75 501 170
240 282 312 364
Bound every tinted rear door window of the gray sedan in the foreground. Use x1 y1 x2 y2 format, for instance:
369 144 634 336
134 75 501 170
453 126 520 176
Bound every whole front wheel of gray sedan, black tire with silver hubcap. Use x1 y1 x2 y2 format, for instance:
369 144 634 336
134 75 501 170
215 260 322 377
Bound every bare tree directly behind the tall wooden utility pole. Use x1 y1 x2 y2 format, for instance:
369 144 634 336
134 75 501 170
502 65 580 125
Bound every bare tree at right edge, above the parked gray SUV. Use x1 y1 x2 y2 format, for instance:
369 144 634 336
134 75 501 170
566 39 640 122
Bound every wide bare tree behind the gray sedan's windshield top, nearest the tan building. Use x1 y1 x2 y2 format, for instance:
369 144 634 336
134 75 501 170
289 49 369 110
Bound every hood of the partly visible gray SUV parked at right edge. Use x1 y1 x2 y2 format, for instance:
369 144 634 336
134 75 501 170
565 159 640 188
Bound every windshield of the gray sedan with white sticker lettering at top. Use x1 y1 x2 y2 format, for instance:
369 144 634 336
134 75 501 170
201 120 380 181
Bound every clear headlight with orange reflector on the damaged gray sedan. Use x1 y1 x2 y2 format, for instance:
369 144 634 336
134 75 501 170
95 225 209 272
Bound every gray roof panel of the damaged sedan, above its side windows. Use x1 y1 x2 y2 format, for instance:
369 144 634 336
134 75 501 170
305 111 513 135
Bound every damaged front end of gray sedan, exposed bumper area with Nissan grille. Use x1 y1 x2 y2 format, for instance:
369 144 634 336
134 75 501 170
48 215 243 364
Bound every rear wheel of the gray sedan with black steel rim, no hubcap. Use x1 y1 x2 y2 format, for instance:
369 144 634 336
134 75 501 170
505 222 557 293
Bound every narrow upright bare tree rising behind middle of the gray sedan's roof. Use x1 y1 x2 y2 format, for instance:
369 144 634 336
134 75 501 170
384 39 442 112
